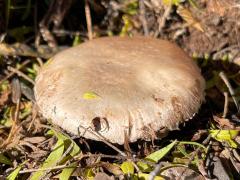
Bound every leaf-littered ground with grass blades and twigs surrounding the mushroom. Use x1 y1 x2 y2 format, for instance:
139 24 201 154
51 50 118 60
0 0 240 179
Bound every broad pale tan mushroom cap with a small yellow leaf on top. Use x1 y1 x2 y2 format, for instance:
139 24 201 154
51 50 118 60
34 37 205 144
